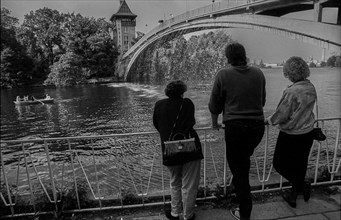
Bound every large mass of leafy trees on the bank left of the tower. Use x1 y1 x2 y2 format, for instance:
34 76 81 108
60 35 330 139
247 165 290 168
1 7 119 87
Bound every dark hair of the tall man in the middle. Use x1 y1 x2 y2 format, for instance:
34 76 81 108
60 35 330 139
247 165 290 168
225 43 247 66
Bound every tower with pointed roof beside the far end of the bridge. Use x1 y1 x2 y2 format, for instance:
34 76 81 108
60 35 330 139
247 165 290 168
110 0 137 54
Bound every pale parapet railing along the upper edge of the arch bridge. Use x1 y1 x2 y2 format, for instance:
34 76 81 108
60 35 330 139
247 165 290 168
123 0 255 59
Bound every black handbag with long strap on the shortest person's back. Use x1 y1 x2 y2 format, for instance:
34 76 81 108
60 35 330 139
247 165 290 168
163 100 197 158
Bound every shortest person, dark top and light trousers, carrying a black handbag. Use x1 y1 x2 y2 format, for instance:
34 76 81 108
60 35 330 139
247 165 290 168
153 80 204 220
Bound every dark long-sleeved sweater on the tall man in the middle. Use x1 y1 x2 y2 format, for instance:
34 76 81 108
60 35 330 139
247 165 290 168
208 66 266 123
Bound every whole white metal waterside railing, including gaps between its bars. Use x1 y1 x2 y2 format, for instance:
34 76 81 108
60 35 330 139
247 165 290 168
0 118 341 217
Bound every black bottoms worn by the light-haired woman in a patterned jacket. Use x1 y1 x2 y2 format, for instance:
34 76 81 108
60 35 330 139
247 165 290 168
273 131 314 193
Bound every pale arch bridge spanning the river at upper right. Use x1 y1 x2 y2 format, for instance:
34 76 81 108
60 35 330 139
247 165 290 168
118 0 341 80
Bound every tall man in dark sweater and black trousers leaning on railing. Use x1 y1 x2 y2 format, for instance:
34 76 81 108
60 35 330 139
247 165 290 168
208 43 266 220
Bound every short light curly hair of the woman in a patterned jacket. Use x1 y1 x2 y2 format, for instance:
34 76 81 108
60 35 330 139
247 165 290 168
283 56 310 82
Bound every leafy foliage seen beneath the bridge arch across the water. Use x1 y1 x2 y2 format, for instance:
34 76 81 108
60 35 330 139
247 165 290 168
129 31 232 84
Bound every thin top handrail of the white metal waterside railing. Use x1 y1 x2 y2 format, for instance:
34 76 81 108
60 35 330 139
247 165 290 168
0 117 341 144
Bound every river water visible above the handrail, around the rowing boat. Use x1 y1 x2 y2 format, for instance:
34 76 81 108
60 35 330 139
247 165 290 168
1 68 341 140
